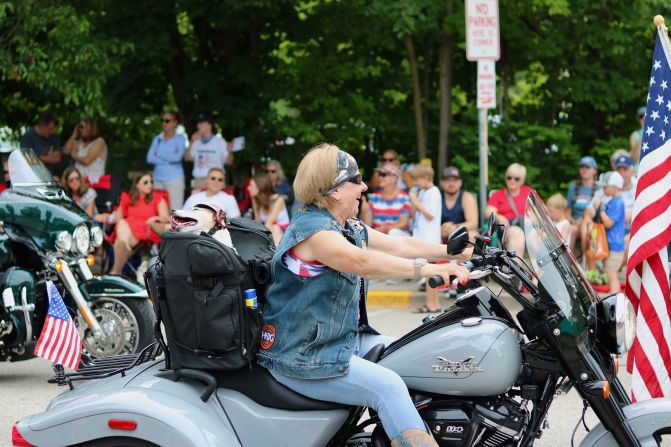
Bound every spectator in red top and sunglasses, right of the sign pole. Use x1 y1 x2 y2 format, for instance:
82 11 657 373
485 163 533 256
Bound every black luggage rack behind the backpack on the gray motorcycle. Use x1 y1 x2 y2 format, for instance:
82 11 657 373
48 342 163 390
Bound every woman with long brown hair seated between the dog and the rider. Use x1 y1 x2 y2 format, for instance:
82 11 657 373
249 173 289 245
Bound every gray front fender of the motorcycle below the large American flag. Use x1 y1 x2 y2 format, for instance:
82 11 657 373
580 398 671 447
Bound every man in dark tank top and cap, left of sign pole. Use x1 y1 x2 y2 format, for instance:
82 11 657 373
440 166 478 240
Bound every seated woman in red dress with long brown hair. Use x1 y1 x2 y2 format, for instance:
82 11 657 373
110 172 170 275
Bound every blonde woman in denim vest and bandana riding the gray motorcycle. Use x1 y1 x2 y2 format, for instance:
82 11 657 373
258 144 468 446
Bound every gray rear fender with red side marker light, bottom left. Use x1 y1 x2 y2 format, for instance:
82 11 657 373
17 379 240 447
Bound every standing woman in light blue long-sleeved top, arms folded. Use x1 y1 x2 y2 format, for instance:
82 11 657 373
147 112 186 210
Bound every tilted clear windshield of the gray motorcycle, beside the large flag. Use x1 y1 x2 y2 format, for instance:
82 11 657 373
524 192 599 337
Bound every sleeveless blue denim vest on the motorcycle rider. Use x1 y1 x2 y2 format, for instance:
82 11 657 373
258 205 375 379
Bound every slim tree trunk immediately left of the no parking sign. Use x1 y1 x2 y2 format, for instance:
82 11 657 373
438 0 454 176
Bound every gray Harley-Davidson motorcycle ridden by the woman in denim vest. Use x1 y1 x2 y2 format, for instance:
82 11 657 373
12 194 671 447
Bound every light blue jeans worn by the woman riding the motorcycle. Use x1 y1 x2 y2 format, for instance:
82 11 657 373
271 334 426 439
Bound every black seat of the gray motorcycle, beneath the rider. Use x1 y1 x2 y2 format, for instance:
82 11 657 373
212 363 349 411
